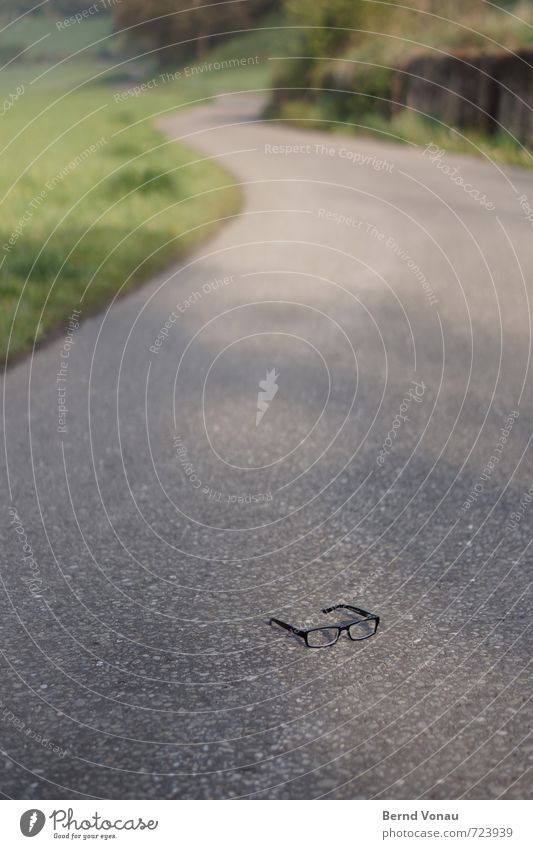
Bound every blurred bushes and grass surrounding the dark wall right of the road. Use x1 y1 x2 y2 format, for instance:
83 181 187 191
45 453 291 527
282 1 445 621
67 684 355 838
267 0 533 167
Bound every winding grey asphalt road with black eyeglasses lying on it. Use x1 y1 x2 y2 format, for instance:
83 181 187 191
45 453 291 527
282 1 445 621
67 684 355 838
0 96 533 799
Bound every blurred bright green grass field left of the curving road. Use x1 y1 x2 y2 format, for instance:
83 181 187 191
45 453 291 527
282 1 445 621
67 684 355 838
0 14 290 360
